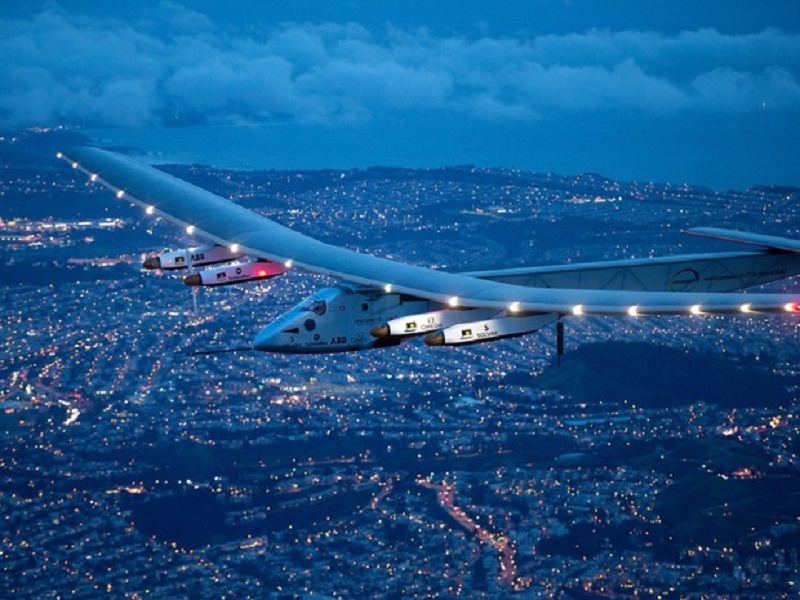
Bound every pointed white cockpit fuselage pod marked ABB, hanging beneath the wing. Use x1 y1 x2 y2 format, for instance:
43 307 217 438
253 285 435 354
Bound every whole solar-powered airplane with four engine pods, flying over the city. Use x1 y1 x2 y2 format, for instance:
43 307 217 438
58 147 800 353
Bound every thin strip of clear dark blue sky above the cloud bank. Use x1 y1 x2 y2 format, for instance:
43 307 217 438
7 0 800 37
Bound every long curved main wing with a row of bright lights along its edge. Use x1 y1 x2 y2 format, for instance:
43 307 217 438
59 147 800 315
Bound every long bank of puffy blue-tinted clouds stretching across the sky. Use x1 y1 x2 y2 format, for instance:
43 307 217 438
0 2 800 126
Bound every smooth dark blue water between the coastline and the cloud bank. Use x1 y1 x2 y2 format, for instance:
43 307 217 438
86 110 800 190
